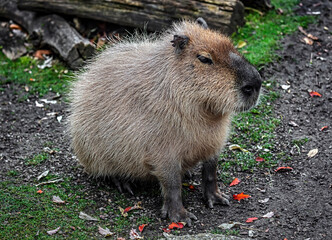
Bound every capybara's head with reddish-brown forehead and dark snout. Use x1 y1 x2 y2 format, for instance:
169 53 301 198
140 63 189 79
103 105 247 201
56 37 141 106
171 18 262 115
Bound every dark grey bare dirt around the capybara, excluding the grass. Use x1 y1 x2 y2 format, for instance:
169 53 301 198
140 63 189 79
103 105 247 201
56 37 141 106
0 0 332 239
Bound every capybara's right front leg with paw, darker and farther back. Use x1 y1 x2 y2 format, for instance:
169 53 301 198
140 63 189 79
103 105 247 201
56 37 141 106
202 157 229 208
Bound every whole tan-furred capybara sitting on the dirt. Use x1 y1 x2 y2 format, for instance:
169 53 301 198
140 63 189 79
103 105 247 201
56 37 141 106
69 18 261 225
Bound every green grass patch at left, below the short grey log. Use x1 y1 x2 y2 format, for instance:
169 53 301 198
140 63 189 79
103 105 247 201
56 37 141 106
0 52 72 97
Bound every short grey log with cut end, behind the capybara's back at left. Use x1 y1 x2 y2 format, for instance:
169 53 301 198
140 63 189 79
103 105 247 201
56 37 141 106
0 0 94 68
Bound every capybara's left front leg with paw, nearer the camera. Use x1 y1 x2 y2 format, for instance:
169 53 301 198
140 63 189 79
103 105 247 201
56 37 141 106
158 164 197 226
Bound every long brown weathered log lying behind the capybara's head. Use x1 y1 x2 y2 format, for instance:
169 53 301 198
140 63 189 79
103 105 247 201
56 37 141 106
18 0 244 34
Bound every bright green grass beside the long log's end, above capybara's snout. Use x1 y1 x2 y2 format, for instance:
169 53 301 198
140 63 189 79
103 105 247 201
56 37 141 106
232 0 314 67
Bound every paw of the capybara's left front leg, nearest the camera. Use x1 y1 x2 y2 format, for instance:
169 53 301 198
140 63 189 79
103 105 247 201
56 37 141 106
161 205 197 227
